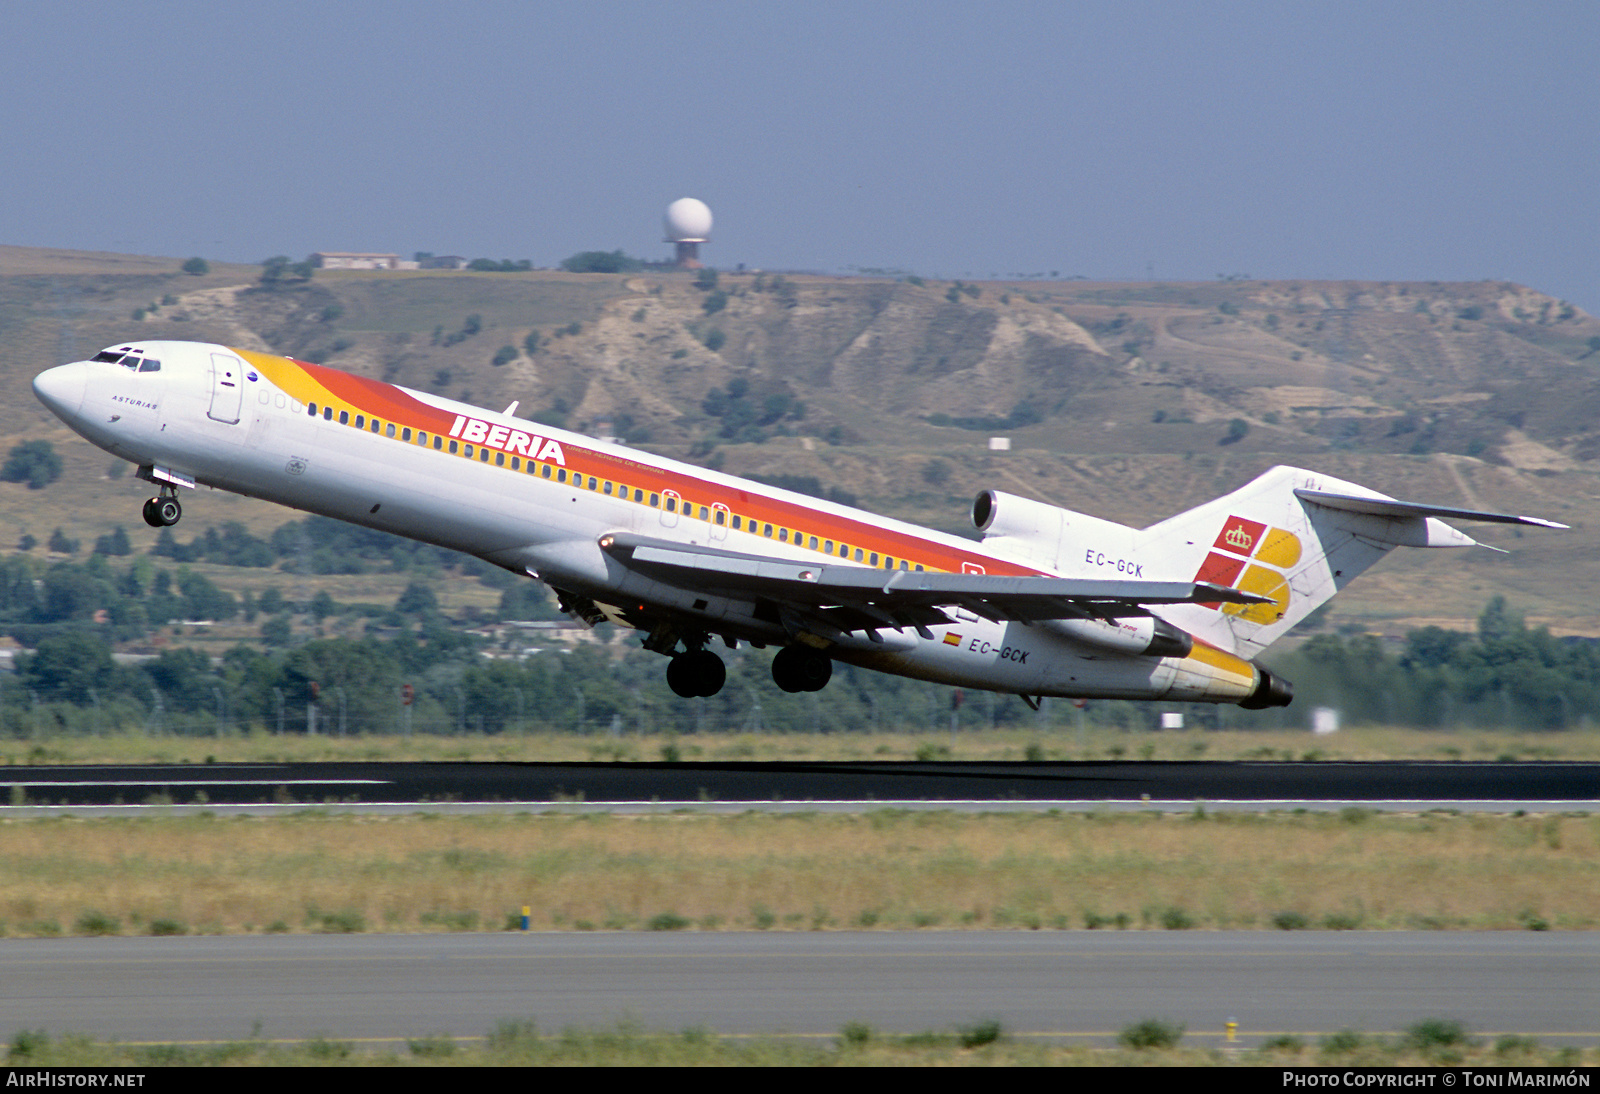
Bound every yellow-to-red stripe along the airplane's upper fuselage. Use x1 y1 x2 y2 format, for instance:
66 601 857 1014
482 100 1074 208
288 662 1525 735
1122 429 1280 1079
234 349 1045 576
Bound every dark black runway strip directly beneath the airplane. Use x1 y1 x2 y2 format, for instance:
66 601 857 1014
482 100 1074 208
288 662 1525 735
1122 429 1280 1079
0 761 1600 811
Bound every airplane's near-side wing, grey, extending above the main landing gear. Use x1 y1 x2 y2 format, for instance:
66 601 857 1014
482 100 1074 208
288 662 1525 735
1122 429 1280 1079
600 533 1270 632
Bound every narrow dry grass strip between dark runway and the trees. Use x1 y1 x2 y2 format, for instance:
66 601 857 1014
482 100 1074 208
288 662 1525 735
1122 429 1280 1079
12 726 1600 765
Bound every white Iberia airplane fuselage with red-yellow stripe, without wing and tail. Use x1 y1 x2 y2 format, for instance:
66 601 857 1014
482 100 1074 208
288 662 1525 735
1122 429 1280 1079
35 342 1256 702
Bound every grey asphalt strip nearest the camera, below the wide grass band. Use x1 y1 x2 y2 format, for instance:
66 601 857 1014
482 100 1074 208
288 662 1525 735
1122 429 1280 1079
0 931 1600 1051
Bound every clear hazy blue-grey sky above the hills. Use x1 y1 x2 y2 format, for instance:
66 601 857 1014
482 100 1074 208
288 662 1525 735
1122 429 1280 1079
0 0 1600 313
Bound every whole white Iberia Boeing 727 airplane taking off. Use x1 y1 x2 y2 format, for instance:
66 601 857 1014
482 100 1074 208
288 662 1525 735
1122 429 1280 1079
34 341 1565 709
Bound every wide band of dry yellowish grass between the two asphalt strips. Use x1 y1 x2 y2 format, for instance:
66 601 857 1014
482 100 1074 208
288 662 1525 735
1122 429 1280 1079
0 811 1600 934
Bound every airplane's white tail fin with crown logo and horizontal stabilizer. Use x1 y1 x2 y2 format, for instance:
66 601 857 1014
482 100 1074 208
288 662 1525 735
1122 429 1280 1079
1138 467 1563 657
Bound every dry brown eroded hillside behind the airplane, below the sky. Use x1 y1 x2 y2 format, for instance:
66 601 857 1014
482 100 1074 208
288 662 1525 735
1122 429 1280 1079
0 248 1600 633
